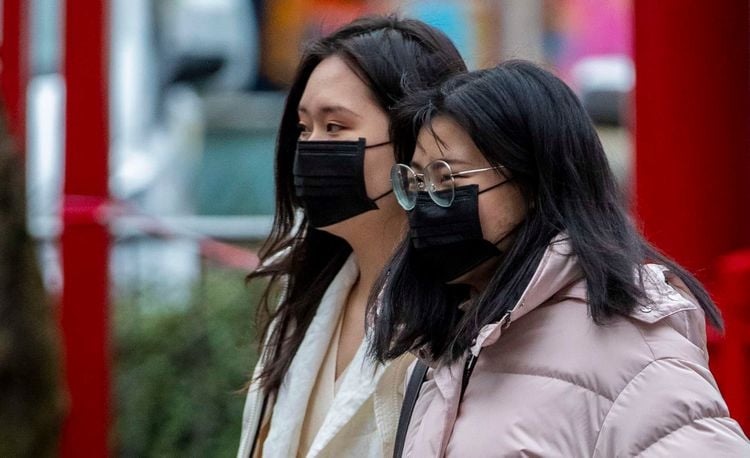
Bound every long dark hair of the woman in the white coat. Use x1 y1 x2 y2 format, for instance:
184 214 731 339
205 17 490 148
248 16 466 393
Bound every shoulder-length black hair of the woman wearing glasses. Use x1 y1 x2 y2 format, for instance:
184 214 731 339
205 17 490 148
368 61 722 363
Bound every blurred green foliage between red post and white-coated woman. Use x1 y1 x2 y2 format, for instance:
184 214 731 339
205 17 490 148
114 269 260 457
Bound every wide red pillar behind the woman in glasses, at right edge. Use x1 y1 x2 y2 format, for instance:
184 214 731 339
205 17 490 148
634 0 750 281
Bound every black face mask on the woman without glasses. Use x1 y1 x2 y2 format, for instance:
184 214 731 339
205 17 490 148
292 138 393 228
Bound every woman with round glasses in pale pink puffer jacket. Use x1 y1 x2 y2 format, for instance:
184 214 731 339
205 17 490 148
369 61 750 458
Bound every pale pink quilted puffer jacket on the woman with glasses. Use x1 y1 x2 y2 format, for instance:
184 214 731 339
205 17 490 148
404 241 750 458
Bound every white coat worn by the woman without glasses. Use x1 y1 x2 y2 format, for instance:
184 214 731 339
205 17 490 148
237 255 413 458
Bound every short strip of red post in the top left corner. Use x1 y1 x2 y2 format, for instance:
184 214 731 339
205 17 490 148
0 0 29 145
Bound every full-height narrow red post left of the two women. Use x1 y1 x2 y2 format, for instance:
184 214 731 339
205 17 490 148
61 0 110 457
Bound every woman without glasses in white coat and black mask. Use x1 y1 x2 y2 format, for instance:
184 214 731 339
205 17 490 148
238 17 465 458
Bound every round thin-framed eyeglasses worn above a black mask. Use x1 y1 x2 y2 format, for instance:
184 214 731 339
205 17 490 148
391 160 505 210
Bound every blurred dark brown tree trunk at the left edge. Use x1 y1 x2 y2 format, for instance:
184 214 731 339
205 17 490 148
0 115 65 458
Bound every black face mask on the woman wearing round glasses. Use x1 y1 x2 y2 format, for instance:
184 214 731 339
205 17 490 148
409 180 507 283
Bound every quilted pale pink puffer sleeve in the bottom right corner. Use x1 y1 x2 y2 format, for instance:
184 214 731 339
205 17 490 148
593 358 750 458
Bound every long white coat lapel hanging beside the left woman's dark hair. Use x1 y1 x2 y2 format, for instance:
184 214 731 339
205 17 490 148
263 255 359 458
